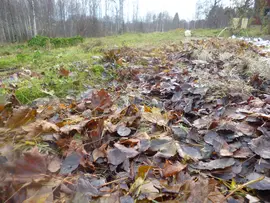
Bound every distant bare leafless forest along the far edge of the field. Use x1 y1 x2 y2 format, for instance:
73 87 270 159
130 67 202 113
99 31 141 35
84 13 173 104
0 0 266 42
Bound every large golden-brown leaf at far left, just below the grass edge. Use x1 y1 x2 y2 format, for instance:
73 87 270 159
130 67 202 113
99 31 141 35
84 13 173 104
6 107 36 128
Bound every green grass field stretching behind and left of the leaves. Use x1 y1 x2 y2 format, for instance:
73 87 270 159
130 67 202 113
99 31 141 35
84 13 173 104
0 29 266 103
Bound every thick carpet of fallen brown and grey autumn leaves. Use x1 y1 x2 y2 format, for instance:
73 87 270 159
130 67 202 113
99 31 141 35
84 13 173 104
0 39 270 202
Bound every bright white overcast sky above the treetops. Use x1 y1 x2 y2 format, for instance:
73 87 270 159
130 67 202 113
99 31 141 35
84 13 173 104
126 0 230 20
